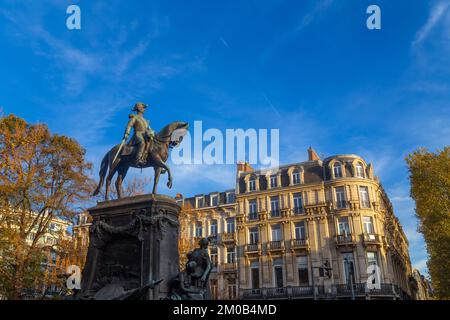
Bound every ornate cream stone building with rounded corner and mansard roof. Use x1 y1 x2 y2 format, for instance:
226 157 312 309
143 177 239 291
180 148 422 299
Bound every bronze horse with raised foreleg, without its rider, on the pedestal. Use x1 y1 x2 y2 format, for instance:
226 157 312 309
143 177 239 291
93 122 189 200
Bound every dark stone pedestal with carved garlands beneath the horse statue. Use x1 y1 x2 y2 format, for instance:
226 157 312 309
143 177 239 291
79 195 180 300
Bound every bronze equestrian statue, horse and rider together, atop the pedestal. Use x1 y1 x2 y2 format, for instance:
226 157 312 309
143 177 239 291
93 102 189 200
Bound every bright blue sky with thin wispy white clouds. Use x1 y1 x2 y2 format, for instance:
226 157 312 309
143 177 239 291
0 0 450 271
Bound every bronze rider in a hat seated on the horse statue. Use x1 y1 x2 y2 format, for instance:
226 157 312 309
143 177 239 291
124 102 155 167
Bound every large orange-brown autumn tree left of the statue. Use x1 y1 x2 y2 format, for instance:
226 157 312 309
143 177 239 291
0 115 94 299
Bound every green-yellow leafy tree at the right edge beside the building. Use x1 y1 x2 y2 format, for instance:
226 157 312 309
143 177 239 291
406 146 450 299
